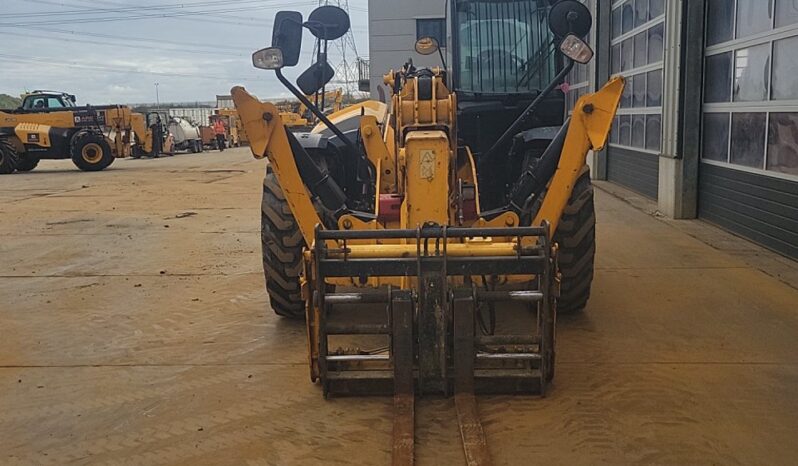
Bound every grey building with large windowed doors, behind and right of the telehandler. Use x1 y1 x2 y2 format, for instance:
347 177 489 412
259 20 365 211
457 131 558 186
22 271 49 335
369 0 798 258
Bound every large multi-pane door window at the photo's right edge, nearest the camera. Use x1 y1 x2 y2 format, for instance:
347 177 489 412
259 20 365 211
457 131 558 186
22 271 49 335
701 0 798 179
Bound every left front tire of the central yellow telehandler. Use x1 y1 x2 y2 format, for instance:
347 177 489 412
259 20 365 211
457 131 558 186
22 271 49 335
261 168 305 319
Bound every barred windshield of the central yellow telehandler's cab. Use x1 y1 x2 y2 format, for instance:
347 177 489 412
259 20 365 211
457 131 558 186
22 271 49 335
455 0 556 94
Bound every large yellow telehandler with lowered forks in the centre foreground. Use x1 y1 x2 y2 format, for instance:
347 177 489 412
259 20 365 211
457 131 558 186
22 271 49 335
232 0 624 464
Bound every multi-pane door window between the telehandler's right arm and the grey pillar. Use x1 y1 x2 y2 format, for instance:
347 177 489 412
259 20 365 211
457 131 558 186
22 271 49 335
610 0 666 153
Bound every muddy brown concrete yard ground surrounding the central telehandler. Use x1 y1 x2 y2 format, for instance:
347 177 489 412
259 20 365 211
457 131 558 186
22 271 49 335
0 149 798 465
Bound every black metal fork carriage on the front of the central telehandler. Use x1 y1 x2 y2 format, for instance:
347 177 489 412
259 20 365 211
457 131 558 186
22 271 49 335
306 224 559 395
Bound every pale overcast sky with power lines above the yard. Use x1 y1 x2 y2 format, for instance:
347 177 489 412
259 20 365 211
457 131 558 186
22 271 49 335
0 0 368 104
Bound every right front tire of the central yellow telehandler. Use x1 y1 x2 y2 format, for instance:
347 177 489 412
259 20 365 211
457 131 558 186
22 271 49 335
554 166 596 314
